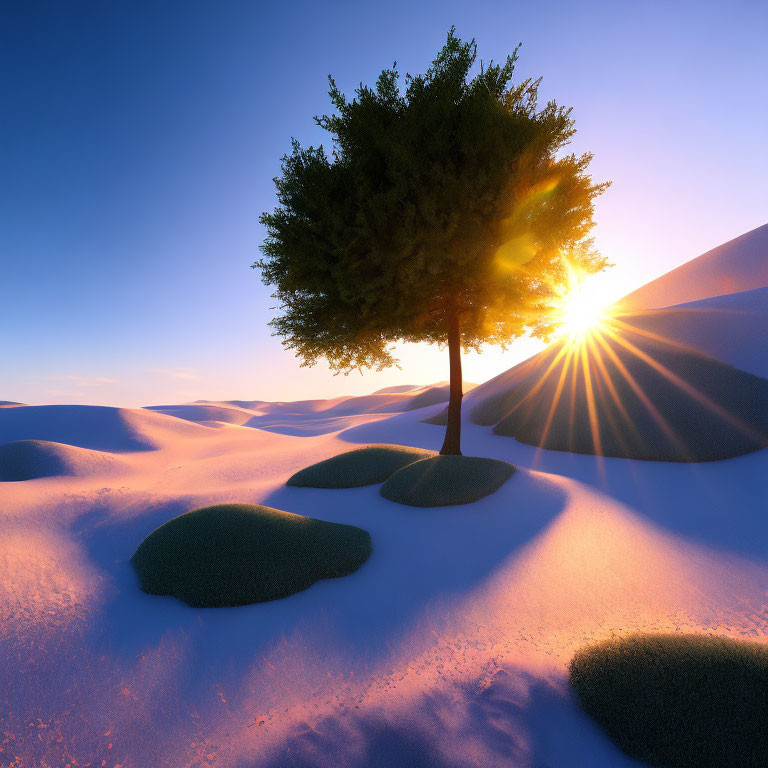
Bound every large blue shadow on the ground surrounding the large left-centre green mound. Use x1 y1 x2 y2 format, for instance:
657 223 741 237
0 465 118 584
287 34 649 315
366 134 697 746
64 471 564 695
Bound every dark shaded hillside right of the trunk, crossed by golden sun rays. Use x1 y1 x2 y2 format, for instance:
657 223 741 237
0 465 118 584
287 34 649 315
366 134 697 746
468 317 768 461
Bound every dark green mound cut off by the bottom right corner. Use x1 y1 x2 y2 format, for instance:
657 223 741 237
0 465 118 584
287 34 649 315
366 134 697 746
570 635 768 768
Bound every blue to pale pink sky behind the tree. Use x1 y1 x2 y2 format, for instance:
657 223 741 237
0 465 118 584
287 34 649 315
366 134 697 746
0 0 768 407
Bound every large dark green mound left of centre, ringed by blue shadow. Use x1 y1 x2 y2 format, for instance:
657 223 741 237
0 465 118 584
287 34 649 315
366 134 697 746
131 504 371 607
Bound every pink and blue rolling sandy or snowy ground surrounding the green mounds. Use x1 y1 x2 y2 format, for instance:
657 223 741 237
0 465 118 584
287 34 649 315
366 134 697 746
0 396 768 768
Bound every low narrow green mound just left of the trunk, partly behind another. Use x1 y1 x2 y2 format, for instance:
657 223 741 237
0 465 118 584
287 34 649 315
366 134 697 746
287 445 435 488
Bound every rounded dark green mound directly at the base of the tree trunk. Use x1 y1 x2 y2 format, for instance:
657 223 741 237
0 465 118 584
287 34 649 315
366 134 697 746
381 456 515 507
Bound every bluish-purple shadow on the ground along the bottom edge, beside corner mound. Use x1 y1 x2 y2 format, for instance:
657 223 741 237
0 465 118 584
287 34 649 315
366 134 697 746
249 668 641 768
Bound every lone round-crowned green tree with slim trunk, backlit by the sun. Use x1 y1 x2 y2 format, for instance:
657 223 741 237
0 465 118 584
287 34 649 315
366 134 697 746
253 29 607 454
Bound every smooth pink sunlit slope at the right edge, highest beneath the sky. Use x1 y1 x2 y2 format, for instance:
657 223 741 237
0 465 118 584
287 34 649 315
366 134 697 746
619 224 768 310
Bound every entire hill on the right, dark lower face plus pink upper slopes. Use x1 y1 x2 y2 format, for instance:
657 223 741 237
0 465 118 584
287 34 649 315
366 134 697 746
440 225 768 461
